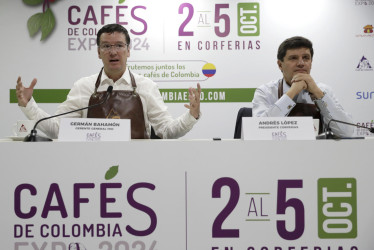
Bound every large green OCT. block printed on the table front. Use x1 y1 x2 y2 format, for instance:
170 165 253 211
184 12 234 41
318 178 357 239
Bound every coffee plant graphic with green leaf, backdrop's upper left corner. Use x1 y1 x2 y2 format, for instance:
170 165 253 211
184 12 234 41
22 0 125 41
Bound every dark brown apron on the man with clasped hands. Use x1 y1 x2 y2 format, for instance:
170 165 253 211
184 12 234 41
278 79 323 133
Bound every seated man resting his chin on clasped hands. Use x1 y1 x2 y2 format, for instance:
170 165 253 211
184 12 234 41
252 36 354 136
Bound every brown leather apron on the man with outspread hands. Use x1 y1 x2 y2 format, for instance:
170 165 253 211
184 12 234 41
87 68 149 139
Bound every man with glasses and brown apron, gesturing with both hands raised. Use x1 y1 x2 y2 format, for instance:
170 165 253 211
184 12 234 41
16 24 201 139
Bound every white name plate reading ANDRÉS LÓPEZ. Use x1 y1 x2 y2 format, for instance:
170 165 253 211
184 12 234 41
242 117 316 141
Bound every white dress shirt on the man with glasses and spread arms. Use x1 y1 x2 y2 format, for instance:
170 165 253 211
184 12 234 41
20 69 197 139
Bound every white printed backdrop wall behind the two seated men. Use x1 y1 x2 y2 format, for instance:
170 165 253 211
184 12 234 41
0 0 374 138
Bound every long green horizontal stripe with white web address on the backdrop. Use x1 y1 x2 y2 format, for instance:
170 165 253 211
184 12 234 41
9 88 256 103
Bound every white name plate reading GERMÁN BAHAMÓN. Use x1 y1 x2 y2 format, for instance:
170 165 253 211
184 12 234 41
58 118 131 142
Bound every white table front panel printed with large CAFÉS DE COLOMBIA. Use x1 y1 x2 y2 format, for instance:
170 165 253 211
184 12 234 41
0 140 374 250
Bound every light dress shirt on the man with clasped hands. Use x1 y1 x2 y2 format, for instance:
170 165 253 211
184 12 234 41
252 79 354 136
